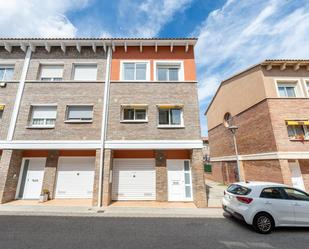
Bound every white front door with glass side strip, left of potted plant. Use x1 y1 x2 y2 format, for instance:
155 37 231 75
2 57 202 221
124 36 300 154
20 158 46 199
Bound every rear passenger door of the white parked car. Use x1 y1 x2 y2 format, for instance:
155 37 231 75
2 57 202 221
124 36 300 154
260 187 295 226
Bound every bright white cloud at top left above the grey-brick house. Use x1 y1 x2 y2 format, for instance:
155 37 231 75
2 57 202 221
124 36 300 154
0 0 89 37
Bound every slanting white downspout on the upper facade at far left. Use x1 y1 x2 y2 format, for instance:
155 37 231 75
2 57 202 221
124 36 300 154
6 47 31 141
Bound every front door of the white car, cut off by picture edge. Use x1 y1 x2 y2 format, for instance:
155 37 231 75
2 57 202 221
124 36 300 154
284 188 309 226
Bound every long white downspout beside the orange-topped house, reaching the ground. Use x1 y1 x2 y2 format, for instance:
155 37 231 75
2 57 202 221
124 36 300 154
98 46 112 207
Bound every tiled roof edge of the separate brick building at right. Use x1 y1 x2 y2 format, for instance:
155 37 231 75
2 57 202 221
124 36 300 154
204 59 309 115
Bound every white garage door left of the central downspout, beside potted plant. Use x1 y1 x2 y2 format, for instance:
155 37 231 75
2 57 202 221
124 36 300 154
55 157 95 198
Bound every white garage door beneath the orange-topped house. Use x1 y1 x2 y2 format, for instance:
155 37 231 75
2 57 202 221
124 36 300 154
112 159 156 200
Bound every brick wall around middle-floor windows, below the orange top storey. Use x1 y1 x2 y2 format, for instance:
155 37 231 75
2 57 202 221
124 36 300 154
107 82 201 140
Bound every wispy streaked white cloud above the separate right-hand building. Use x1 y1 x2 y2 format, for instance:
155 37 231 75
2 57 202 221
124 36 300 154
193 0 309 133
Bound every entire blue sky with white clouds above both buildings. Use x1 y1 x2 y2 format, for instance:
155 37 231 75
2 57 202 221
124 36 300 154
0 0 309 135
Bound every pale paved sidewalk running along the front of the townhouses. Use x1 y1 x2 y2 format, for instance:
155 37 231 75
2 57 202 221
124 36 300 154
0 204 223 218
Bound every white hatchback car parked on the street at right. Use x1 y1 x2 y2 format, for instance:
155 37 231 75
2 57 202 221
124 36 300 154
222 182 309 234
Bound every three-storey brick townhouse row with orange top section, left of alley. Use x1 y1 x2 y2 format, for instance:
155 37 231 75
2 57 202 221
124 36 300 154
0 38 207 207
